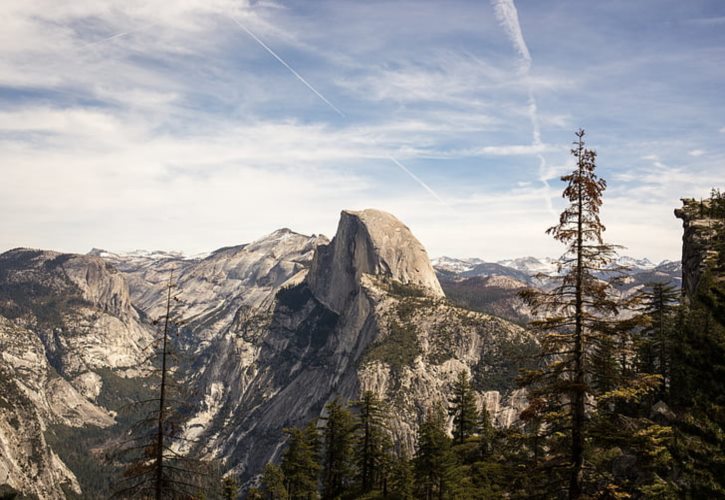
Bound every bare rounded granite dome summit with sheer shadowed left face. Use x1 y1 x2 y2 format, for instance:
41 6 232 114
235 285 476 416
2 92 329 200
307 209 444 312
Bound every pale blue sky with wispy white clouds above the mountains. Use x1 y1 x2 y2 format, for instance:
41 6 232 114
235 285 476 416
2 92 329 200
0 0 725 261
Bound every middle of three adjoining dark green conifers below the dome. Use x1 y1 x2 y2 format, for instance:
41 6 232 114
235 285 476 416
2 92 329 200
322 399 354 499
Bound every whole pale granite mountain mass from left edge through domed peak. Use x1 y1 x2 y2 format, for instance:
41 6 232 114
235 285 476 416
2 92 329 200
0 210 537 498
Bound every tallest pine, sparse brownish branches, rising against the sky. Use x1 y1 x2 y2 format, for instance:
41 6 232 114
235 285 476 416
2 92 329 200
523 130 618 499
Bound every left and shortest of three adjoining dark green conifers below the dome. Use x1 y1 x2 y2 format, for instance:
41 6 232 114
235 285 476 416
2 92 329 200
281 422 320 500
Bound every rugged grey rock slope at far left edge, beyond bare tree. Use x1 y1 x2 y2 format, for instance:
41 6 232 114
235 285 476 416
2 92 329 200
0 249 151 498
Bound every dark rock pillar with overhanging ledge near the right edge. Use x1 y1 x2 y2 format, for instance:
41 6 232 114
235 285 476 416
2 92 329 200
675 198 717 297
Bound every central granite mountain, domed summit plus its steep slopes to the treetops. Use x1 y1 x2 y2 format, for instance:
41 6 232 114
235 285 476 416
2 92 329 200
180 210 533 478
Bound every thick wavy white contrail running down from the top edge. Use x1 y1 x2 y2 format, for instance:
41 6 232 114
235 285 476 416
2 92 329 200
491 0 556 217
